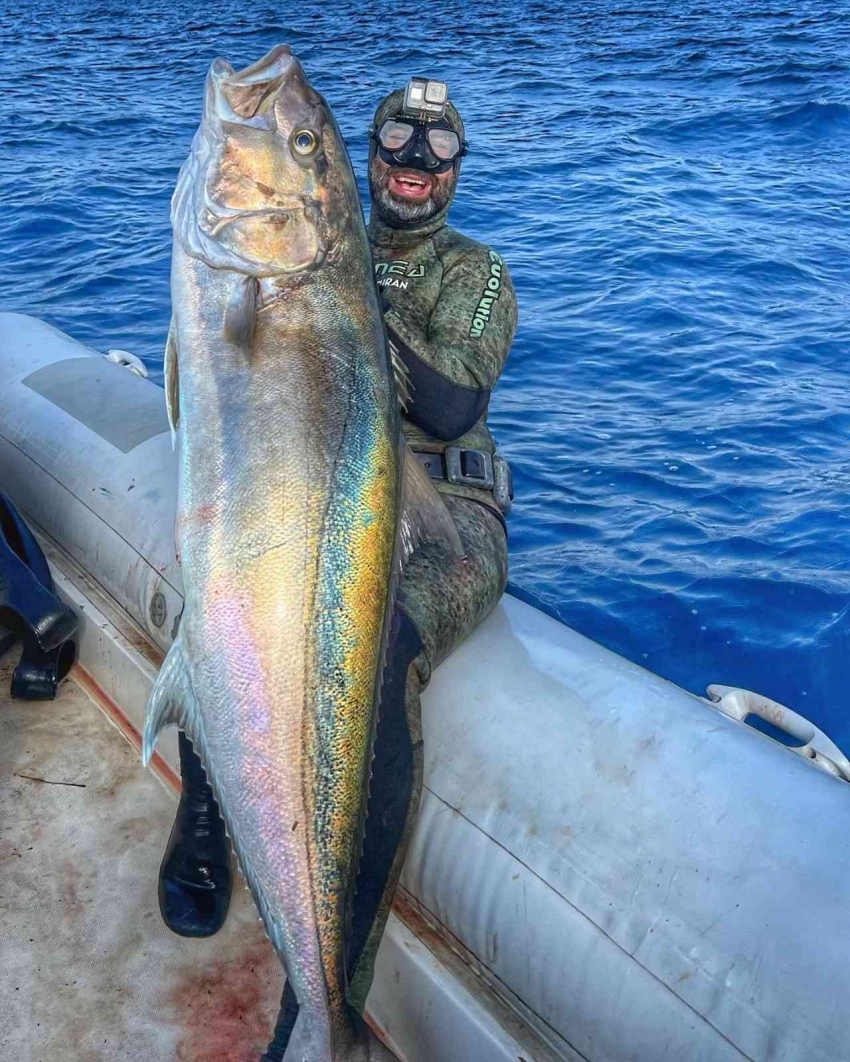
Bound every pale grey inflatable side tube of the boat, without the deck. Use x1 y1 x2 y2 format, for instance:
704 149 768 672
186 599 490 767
0 313 850 1062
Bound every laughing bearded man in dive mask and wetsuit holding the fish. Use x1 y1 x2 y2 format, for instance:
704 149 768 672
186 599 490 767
159 78 516 1062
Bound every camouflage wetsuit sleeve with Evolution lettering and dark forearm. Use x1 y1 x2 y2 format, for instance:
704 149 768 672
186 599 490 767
384 247 516 441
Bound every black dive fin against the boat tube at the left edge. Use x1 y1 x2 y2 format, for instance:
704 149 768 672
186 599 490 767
0 493 78 701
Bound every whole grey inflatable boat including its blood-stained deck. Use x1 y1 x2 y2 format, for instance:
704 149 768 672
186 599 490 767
0 313 850 1062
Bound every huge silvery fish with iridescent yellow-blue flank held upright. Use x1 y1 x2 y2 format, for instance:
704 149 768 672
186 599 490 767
143 47 459 1062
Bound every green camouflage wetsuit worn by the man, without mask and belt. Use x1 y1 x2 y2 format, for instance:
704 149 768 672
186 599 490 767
264 92 516 1062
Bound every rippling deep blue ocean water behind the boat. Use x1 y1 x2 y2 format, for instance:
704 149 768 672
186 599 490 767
0 0 850 749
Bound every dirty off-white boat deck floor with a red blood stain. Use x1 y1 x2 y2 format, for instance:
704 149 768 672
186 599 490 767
0 647 283 1062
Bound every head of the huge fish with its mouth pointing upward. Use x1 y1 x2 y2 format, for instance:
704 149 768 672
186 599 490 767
172 45 360 277
